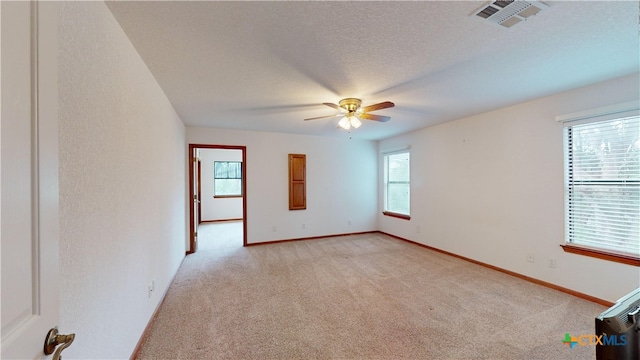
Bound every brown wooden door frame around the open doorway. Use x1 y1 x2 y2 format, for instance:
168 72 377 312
187 144 247 254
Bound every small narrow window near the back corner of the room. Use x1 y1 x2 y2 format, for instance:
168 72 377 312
384 151 411 219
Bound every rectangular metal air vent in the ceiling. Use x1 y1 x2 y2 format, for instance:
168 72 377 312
471 0 549 28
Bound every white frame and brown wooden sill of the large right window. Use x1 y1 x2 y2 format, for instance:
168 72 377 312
556 102 640 266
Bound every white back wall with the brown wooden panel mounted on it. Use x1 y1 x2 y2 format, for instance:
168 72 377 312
187 127 378 243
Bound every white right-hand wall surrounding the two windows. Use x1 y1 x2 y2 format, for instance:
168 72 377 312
379 74 640 301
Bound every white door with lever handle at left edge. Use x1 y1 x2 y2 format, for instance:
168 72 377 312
0 1 65 359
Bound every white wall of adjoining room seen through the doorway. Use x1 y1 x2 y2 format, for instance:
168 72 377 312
199 149 242 221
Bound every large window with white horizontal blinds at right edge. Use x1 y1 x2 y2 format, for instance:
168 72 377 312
565 115 640 258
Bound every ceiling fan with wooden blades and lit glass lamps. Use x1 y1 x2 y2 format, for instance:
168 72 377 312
304 98 395 130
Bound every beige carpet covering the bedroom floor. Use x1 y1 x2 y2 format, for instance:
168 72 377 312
139 223 605 360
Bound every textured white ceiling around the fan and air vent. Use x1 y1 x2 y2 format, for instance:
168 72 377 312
107 1 640 139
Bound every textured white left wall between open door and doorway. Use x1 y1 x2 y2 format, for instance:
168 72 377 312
59 2 186 359
